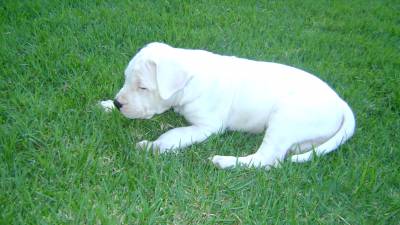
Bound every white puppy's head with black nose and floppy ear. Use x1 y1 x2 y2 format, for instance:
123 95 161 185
114 43 189 119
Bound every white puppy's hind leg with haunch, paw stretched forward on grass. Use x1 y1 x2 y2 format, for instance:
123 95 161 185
211 100 343 169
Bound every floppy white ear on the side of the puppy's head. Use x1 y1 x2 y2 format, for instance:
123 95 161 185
150 59 191 100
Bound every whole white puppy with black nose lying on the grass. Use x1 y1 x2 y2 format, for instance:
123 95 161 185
104 43 355 168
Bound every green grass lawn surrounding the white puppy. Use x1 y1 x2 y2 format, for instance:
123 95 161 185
0 0 400 225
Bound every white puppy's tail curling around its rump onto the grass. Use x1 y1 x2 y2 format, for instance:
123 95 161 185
291 101 356 163
